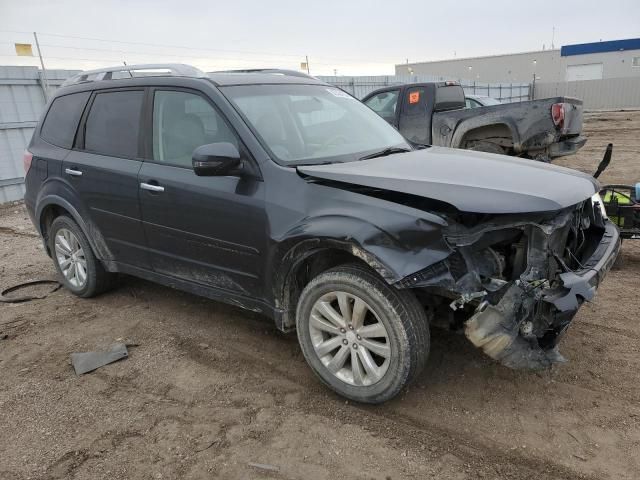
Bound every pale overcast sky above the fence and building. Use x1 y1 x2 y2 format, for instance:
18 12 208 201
0 0 640 75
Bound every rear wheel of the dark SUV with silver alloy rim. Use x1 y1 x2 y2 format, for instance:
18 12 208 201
48 216 116 298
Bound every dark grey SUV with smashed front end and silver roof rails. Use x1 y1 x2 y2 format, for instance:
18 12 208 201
25 65 619 403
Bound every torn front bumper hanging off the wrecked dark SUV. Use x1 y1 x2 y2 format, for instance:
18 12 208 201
465 222 620 370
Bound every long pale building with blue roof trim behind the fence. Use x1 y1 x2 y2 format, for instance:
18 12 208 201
396 38 640 82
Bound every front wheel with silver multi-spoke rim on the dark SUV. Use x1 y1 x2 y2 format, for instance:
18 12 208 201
296 265 430 404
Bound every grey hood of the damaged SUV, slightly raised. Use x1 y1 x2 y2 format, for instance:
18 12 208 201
298 147 599 213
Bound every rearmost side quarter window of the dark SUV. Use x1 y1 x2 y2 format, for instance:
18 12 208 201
40 92 90 148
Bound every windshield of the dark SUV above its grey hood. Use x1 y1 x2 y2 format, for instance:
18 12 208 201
221 84 411 165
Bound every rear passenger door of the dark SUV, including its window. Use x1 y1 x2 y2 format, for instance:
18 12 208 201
62 88 150 268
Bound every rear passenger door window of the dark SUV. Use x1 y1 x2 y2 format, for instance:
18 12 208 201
84 90 144 158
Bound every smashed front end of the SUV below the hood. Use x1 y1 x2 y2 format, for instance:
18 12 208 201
401 197 619 369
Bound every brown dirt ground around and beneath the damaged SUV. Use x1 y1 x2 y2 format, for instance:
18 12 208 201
0 112 640 480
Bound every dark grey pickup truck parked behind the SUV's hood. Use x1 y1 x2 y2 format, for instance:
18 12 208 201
362 82 587 162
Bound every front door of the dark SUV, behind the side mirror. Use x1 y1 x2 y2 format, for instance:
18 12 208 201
139 88 266 297
